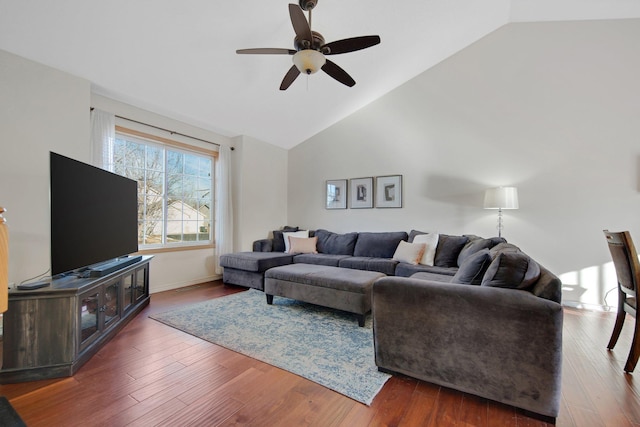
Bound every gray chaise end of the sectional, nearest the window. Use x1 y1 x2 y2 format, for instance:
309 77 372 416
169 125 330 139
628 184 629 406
220 252 293 290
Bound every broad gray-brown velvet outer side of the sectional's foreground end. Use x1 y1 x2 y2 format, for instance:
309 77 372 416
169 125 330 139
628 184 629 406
372 277 563 417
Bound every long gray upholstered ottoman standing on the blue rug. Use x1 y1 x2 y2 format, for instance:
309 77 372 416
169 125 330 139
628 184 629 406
264 264 386 326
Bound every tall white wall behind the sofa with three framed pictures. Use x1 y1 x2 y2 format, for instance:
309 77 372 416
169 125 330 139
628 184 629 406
288 20 640 310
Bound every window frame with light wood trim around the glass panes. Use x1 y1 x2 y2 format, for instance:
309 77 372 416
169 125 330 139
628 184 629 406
109 125 218 254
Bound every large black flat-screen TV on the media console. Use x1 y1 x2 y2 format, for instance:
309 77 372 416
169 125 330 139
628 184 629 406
50 152 138 276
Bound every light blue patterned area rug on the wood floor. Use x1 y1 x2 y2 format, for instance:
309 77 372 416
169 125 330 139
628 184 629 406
150 289 390 405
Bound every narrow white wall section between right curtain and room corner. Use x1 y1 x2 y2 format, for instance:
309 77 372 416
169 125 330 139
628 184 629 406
231 136 288 251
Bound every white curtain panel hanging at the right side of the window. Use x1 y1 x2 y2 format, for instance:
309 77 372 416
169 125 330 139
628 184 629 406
214 145 233 274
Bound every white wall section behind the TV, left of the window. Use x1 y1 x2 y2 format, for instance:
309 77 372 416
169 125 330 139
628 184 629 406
0 50 90 282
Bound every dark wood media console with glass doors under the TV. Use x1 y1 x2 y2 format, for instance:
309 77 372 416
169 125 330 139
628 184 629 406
0 256 152 384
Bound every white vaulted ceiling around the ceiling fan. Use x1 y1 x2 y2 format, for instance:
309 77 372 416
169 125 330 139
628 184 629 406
0 0 640 148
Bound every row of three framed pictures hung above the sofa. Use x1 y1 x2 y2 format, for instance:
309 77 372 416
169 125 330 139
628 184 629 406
325 175 402 209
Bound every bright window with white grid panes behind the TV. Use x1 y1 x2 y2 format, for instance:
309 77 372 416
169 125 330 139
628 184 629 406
109 127 215 250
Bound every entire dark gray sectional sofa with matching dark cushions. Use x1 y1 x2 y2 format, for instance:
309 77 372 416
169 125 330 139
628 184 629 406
221 227 563 422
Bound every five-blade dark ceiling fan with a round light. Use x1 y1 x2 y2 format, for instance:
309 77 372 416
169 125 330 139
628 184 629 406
236 0 380 90
